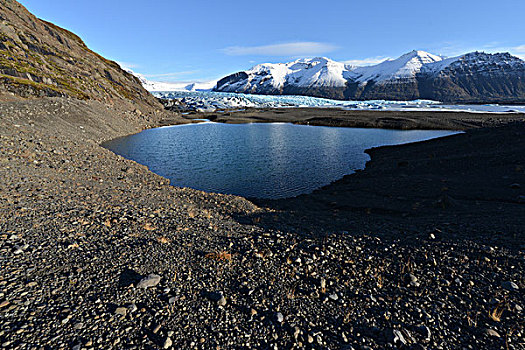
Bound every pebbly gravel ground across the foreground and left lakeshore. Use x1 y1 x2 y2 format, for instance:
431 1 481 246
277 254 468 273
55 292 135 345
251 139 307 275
0 99 525 349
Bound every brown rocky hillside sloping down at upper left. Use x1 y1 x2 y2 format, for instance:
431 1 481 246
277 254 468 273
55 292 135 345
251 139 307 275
0 0 162 111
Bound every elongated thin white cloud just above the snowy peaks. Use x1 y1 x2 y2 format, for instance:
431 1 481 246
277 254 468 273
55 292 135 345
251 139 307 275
221 41 338 56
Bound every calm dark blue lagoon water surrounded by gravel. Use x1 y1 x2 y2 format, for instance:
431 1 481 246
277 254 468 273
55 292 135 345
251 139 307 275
103 123 456 198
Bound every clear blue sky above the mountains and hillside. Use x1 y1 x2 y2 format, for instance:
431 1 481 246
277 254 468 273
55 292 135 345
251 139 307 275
21 0 525 81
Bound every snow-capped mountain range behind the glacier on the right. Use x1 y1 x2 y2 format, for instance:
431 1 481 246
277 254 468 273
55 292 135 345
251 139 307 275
214 51 525 102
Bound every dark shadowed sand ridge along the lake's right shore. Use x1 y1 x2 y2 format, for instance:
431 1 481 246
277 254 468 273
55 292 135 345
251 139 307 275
254 123 525 250
